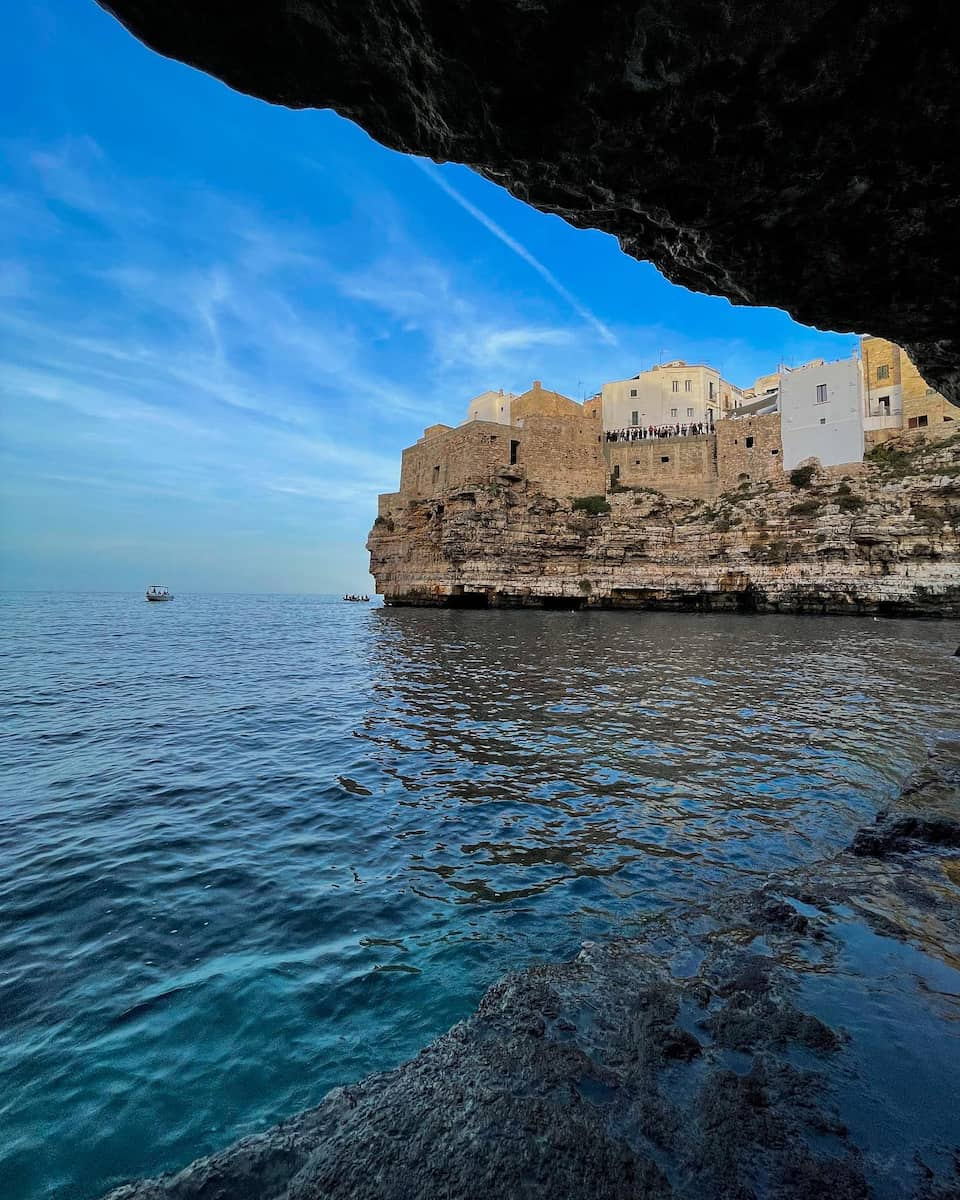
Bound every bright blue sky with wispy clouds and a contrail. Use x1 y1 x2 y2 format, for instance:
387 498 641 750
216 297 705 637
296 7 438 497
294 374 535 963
0 0 853 592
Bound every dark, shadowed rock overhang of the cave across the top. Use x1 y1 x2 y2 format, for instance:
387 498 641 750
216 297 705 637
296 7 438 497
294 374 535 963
93 0 960 398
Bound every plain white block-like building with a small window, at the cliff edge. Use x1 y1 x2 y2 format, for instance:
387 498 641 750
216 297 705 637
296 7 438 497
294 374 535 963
780 354 864 470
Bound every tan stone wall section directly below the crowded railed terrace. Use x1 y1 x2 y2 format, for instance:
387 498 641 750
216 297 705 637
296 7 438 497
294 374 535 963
612 433 720 500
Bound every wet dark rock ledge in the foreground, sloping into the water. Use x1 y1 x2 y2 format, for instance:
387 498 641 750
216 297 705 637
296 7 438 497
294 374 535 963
103 745 960 1200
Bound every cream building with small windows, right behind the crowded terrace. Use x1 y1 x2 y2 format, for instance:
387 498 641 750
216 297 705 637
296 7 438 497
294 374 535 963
601 359 743 430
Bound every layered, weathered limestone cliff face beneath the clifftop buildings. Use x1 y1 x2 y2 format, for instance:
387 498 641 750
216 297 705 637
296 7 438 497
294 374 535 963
367 436 960 617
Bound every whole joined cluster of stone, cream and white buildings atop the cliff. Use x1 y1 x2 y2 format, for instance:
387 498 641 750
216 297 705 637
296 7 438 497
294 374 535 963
380 337 960 525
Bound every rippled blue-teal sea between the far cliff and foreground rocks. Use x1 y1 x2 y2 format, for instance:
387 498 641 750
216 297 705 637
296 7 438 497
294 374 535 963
0 595 958 1200
